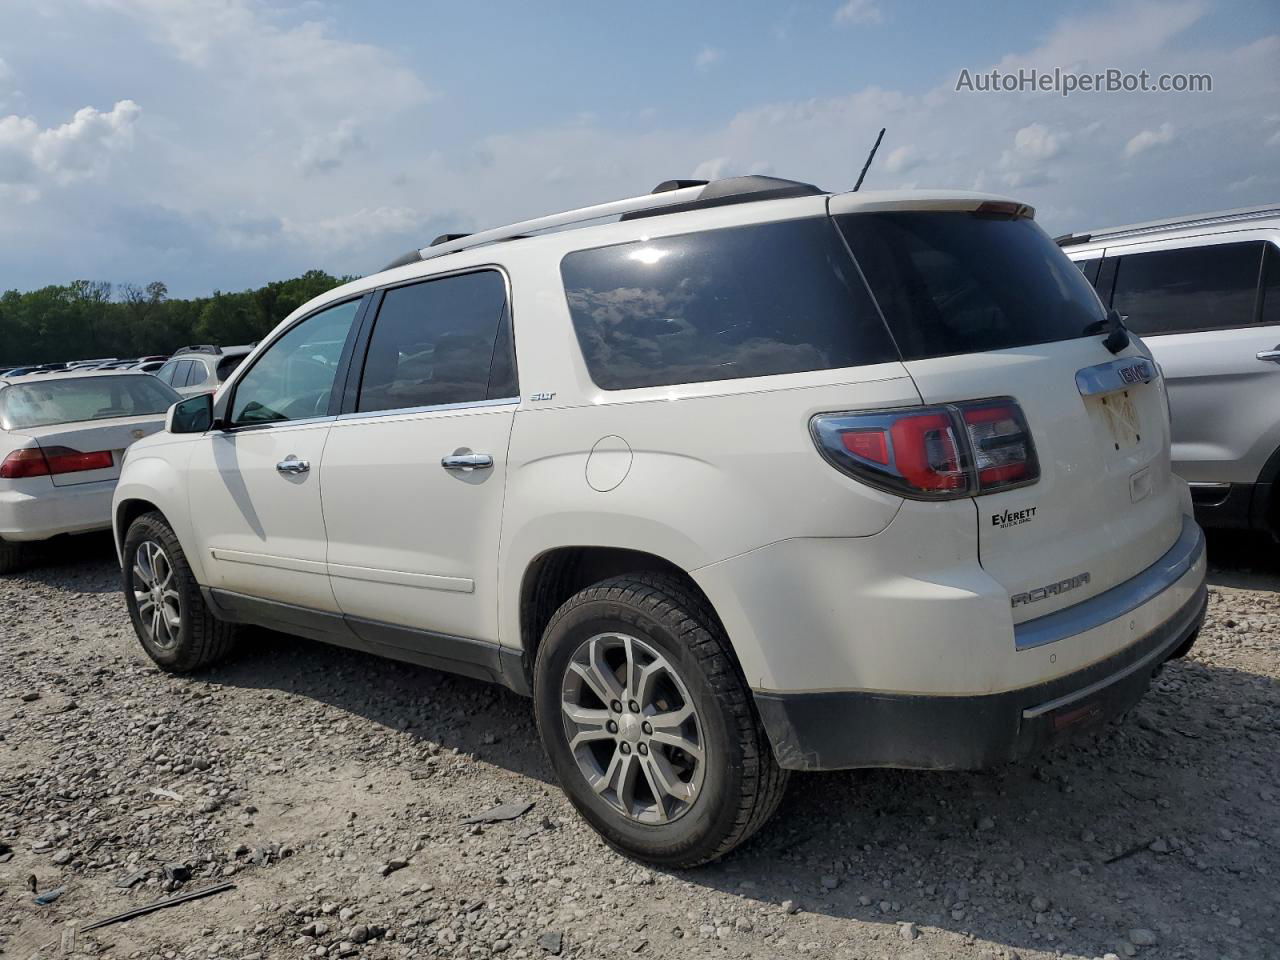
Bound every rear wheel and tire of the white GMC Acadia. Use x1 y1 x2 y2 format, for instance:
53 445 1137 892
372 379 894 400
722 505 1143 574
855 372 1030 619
534 573 788 868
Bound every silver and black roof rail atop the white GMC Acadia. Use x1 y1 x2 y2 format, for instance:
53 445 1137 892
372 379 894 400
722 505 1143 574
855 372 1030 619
383 177 826 270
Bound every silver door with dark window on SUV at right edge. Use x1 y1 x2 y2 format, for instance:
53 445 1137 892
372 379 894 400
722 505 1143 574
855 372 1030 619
1107 230 1280 485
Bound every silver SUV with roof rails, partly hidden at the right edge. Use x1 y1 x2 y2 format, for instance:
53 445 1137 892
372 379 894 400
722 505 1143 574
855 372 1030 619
1057 204 1280 536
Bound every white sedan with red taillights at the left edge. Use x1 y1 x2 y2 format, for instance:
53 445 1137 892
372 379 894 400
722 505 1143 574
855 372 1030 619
0 370 180 573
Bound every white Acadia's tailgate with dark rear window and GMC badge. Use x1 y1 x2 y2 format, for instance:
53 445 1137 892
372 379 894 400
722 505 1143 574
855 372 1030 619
837 203 1181 622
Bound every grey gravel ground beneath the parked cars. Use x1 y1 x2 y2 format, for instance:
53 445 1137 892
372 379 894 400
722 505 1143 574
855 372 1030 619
0 538 1280 960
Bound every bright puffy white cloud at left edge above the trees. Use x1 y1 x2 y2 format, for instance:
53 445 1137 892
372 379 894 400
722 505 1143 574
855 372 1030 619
0 100 142 195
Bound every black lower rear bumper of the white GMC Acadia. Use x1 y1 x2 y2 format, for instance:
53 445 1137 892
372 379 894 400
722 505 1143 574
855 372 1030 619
755 526 1208 771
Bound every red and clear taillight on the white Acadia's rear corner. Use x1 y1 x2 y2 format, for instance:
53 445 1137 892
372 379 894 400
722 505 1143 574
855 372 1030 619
812 397 1039 500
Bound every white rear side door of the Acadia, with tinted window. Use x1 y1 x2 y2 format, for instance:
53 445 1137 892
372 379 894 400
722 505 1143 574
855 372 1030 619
320 270 518 658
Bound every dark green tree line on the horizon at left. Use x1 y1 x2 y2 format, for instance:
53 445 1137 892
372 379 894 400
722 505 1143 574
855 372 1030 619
0 270 351 367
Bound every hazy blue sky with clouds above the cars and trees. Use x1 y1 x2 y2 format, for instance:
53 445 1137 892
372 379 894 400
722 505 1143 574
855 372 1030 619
0 0 1280 296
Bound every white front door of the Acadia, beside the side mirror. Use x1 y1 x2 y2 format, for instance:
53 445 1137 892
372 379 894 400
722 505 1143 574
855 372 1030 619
189 300 360 612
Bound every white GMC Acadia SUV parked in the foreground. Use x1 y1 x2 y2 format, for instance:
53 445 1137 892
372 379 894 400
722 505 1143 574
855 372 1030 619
114 177 1206 867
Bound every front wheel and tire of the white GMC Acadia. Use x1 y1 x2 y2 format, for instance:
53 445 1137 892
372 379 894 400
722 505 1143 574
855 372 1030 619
123 512 236 673
